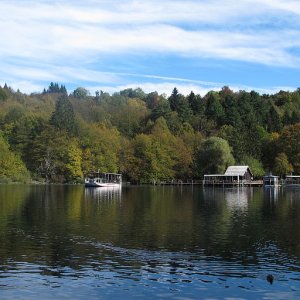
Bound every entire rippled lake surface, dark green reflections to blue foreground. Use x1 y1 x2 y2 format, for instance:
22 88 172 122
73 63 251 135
0 185 300 300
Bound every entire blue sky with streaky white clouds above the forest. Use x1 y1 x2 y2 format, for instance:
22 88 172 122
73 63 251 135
0 0 300 96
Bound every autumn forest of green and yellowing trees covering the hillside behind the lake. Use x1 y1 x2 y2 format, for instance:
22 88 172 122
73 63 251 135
0 83 300 184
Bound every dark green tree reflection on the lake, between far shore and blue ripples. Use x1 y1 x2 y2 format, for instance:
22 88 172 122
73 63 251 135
0 186 300 261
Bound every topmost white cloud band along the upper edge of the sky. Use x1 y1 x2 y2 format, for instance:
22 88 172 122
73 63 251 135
1 0 300 25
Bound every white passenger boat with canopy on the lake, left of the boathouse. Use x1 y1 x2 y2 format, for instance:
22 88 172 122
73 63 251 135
84 171 122 187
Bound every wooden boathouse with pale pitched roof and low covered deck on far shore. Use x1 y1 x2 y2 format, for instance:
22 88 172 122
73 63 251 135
203 166 253 186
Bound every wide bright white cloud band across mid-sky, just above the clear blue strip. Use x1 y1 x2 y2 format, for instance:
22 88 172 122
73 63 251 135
0 20 300 67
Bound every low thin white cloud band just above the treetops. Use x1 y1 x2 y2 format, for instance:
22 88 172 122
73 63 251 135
0 68 295 96
